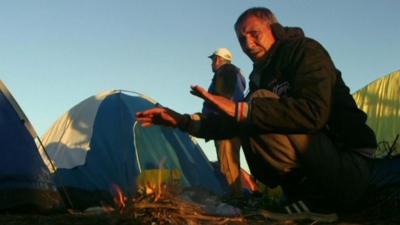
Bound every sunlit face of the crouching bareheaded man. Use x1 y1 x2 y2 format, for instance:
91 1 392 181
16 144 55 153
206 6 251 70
236 16 275 62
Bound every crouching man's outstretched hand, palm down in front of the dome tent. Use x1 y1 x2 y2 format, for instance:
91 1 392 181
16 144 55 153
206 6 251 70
136 107 182 127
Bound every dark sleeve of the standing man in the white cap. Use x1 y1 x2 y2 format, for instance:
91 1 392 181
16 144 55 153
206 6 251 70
214 64 238 99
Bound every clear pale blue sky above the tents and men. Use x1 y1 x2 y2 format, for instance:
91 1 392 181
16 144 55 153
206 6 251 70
0 0 400 165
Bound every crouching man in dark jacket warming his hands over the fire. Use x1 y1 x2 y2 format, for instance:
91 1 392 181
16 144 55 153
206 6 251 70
137 7 400 212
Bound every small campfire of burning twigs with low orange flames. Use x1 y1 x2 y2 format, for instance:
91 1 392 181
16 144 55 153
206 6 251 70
114 166 246 225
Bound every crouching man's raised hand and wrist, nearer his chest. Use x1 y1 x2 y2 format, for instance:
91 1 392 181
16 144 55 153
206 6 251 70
190 85 236 117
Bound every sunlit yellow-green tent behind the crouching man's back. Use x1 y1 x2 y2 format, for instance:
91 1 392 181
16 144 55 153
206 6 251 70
353 71 400 156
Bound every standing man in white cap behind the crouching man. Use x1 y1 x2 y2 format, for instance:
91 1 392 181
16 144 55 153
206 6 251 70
202 48 246 196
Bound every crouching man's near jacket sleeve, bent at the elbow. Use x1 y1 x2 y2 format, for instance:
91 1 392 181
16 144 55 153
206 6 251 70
245 39 337 134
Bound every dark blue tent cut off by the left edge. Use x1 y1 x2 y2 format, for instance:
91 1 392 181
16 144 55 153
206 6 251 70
0 81 62 212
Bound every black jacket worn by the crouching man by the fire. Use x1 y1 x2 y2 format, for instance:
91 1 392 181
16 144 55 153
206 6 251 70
192 24 377 149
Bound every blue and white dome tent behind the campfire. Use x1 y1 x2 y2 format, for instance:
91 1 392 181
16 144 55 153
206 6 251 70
42 90 226 209
